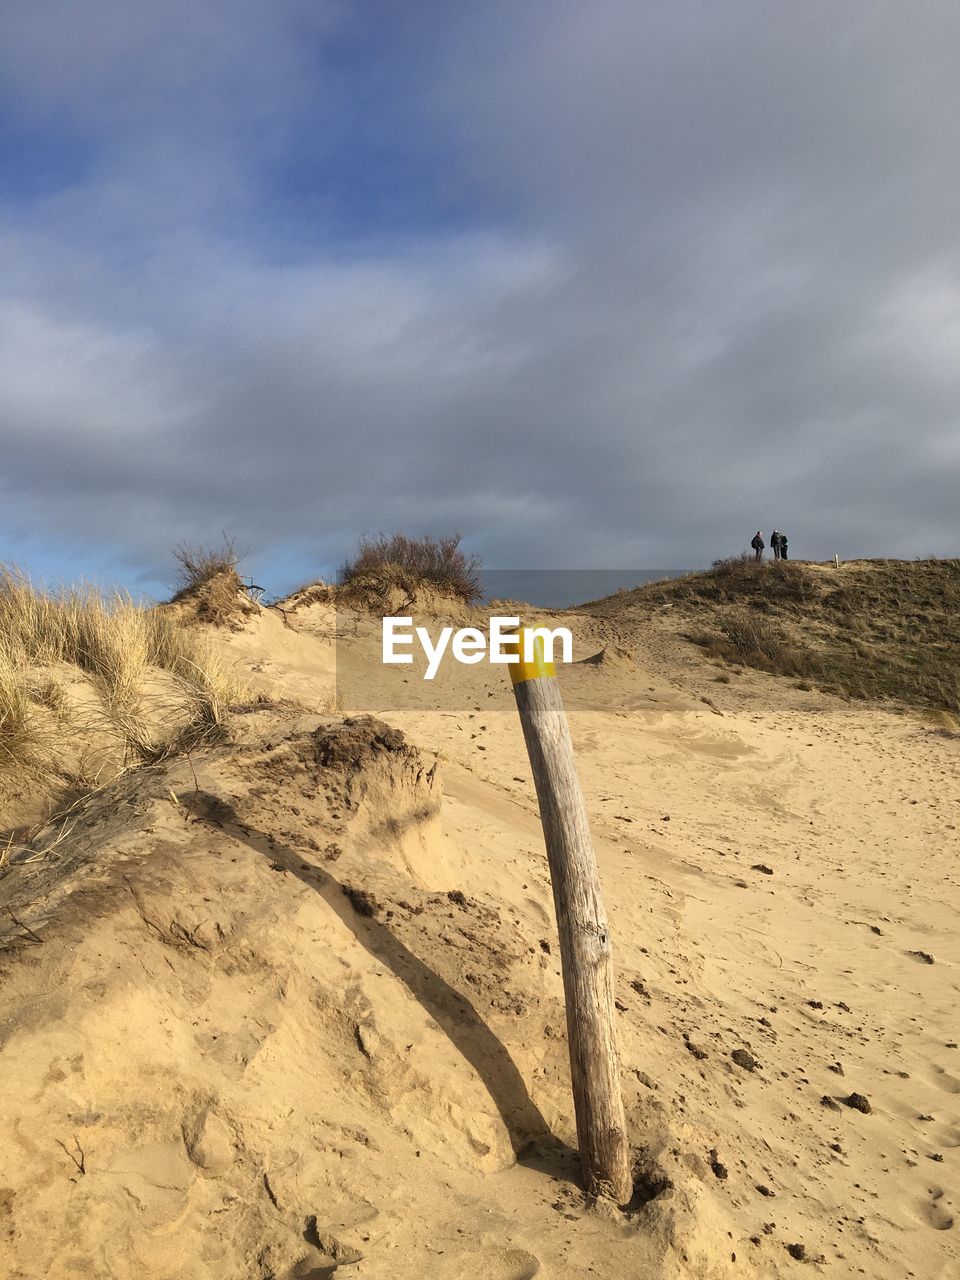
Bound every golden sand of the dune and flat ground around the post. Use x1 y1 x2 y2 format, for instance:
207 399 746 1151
0 586 960 1280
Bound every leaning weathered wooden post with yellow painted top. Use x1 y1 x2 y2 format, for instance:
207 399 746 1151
509 631 634 1204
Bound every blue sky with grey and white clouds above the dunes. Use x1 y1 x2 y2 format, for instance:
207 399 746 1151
0 0 960 595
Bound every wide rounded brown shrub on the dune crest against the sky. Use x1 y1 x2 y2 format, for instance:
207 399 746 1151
339 534 483 604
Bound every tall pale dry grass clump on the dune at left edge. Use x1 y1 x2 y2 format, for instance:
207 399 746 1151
0 567 243 803
